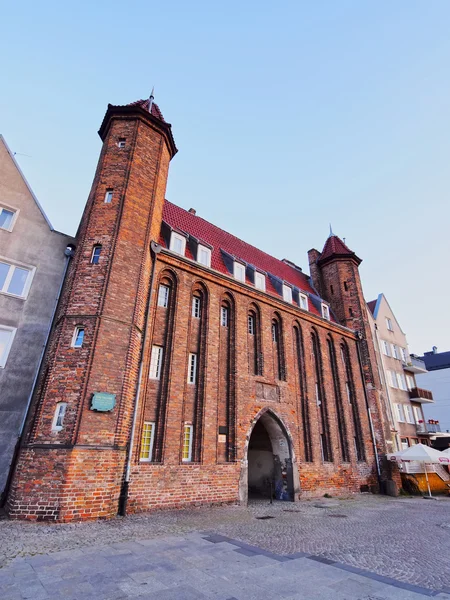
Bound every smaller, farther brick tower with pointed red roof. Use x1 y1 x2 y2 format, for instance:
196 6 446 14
308 233 391 480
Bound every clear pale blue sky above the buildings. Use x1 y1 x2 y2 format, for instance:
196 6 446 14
0 0 450 353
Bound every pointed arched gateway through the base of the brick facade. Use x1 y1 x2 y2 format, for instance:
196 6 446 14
239 409 300 504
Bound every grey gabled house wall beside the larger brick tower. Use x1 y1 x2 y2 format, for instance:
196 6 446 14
0 136 73 494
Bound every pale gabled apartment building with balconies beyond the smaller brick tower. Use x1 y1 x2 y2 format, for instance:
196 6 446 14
368 294 434 451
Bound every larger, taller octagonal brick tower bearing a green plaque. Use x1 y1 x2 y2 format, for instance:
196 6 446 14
7 96 177 521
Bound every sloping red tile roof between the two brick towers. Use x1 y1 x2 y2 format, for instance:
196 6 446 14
160 200 326 314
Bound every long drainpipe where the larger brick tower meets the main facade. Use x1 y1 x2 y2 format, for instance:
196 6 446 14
118 242 161 517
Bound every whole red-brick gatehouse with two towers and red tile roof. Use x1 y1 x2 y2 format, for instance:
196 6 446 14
7 97 389 521
